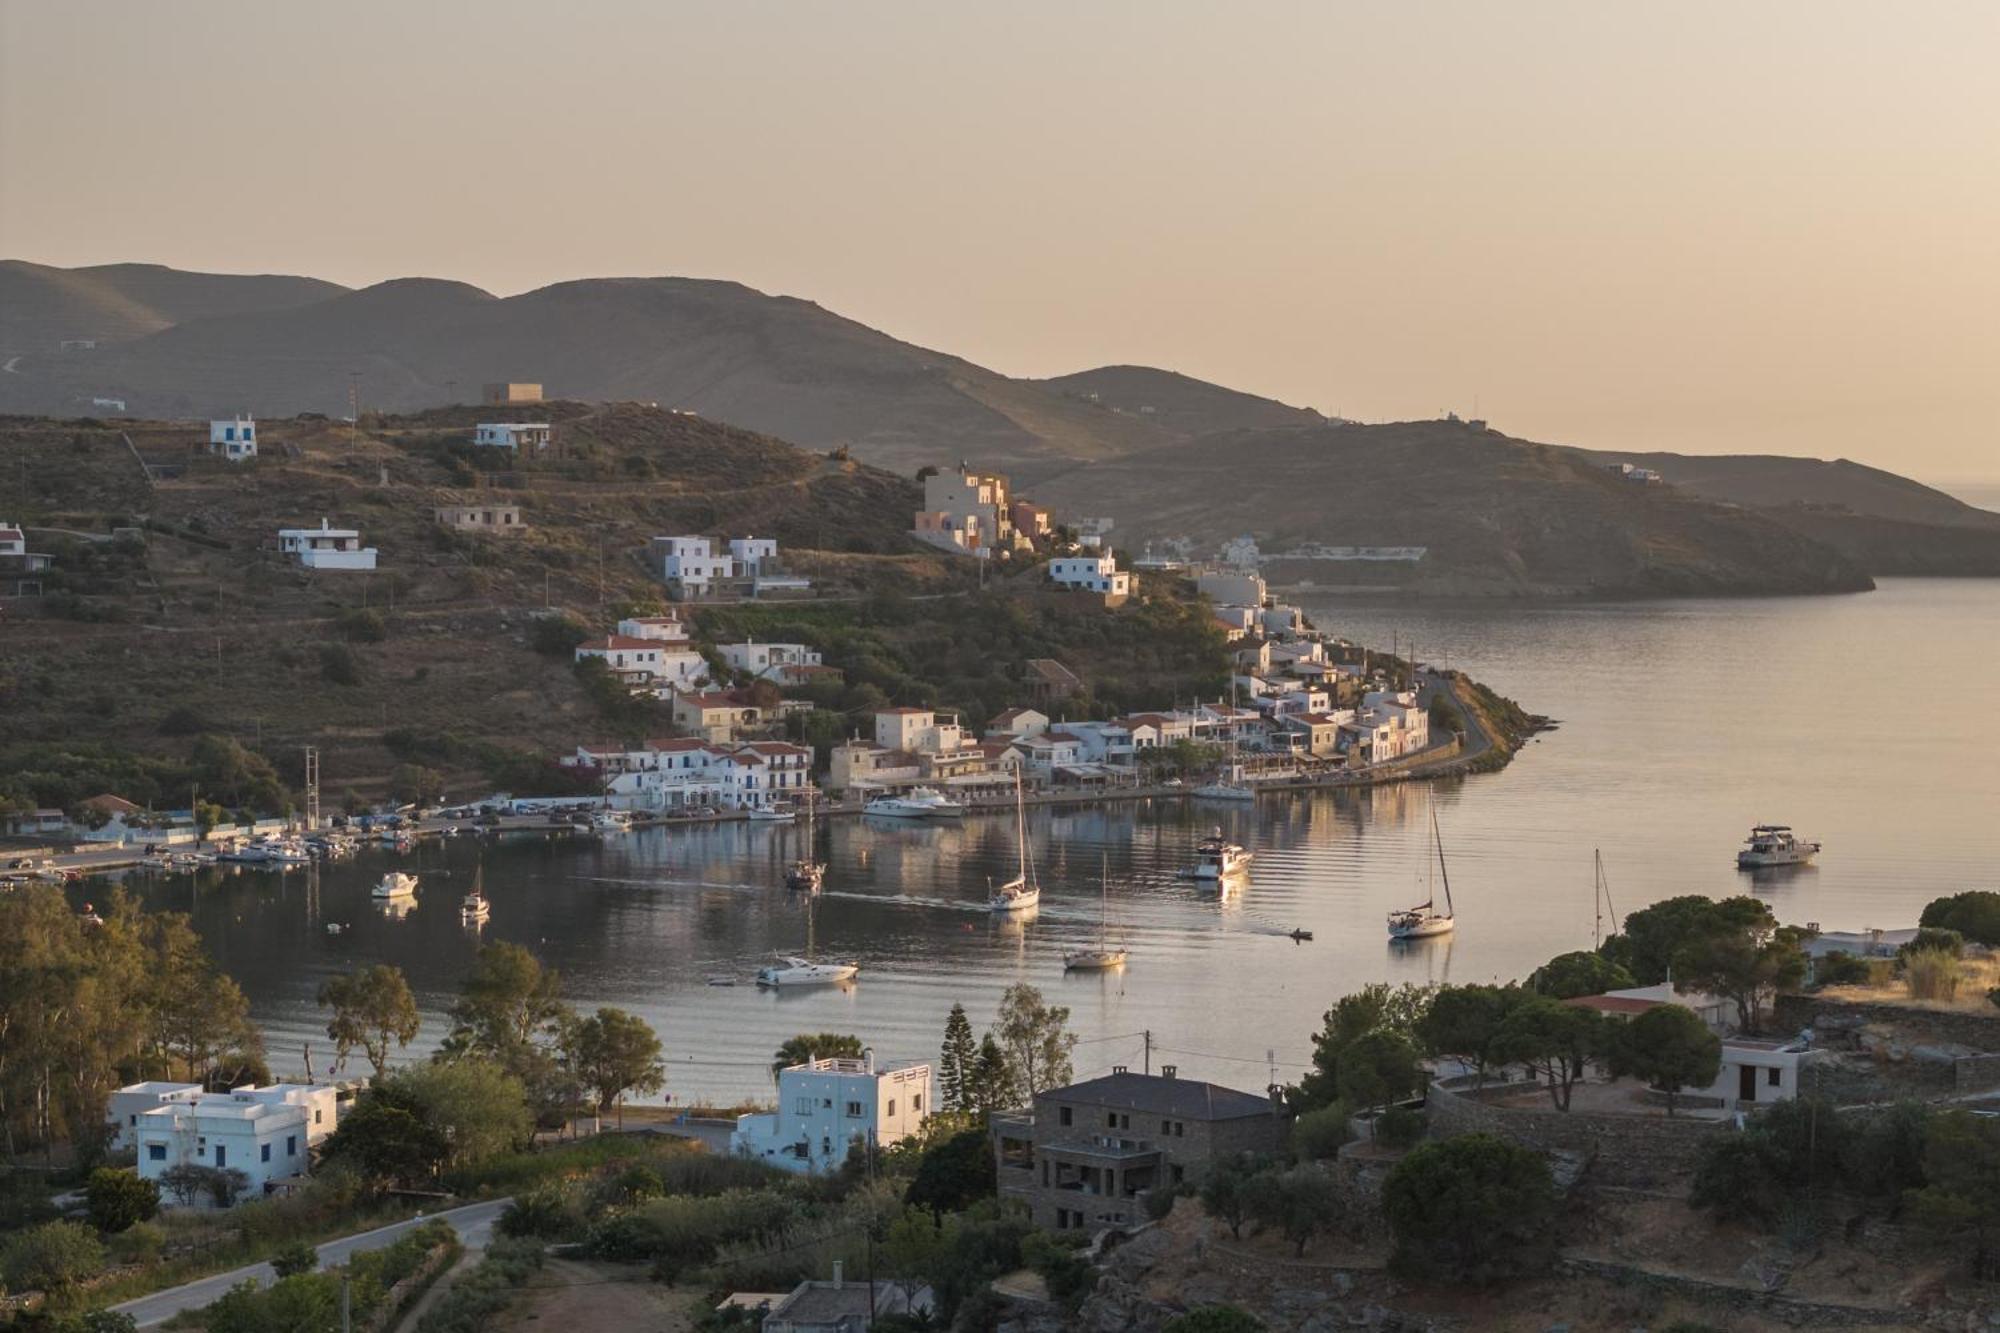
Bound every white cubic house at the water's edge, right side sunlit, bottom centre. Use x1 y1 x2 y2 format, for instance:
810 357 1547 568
730 1053 930 1173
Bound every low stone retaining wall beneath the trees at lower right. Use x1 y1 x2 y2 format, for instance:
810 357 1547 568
1428 1083 1734 1189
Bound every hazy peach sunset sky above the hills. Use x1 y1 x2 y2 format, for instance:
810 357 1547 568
11 0 2000 482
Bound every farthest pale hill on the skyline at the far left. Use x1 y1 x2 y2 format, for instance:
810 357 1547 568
0 260 346 358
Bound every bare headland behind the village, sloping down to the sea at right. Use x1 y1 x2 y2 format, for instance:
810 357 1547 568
1038 422 1872 596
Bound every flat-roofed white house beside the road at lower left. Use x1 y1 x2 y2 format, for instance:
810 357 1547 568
126 1083 336 1197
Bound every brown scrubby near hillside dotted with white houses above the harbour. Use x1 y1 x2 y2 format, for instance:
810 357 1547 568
0 402 1228 805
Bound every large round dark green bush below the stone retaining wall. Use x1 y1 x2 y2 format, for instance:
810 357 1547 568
1382 1135 1556 1283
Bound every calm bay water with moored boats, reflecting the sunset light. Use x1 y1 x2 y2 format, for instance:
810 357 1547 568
146 580 2000 1101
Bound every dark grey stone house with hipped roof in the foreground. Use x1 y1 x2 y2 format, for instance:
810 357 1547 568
992 1065 1290 1231
